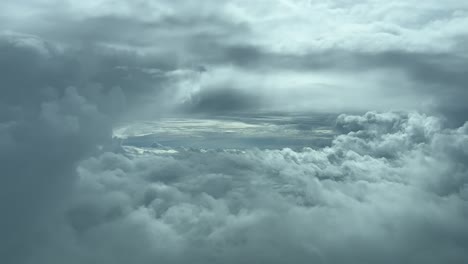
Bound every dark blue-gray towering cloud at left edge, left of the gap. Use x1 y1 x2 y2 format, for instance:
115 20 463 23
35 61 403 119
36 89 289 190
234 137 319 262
0 85 111 263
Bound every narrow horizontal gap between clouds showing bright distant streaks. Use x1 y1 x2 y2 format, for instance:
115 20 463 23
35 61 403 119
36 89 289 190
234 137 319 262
114 113 337 152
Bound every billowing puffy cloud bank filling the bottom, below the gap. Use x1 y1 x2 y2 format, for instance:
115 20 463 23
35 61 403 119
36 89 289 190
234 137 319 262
14 112 460 263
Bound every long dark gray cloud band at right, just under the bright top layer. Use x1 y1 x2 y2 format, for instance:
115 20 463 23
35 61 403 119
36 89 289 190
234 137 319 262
184 45 468 122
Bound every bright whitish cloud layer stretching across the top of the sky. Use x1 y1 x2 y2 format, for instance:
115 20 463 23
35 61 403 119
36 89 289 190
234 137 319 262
2 0 468 54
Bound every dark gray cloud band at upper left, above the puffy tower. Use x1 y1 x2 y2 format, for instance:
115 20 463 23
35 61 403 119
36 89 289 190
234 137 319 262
0 34 169 109
